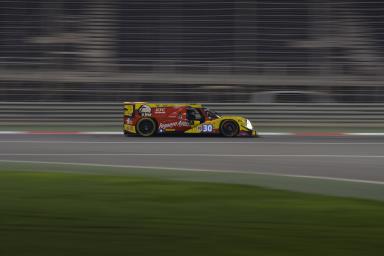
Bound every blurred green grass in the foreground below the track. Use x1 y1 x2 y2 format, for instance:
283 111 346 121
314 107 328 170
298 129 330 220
0 172 384 256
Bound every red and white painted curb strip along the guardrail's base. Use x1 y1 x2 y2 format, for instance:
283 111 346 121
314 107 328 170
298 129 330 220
0 131 384 137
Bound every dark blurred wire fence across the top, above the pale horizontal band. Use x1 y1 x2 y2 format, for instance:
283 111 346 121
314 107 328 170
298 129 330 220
0 0 384 77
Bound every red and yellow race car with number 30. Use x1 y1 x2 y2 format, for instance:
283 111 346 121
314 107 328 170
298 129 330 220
124 102 257 137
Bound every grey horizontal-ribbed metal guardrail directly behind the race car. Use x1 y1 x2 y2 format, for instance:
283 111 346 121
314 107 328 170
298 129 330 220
0 102 384 128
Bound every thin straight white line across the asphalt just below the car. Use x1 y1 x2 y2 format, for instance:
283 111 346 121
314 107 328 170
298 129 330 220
0 153 384 158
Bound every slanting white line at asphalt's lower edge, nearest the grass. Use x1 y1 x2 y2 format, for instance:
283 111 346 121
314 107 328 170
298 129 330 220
0 159 384 185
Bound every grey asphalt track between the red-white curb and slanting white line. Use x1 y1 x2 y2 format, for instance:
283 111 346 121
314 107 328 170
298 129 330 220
0 134 384 182
